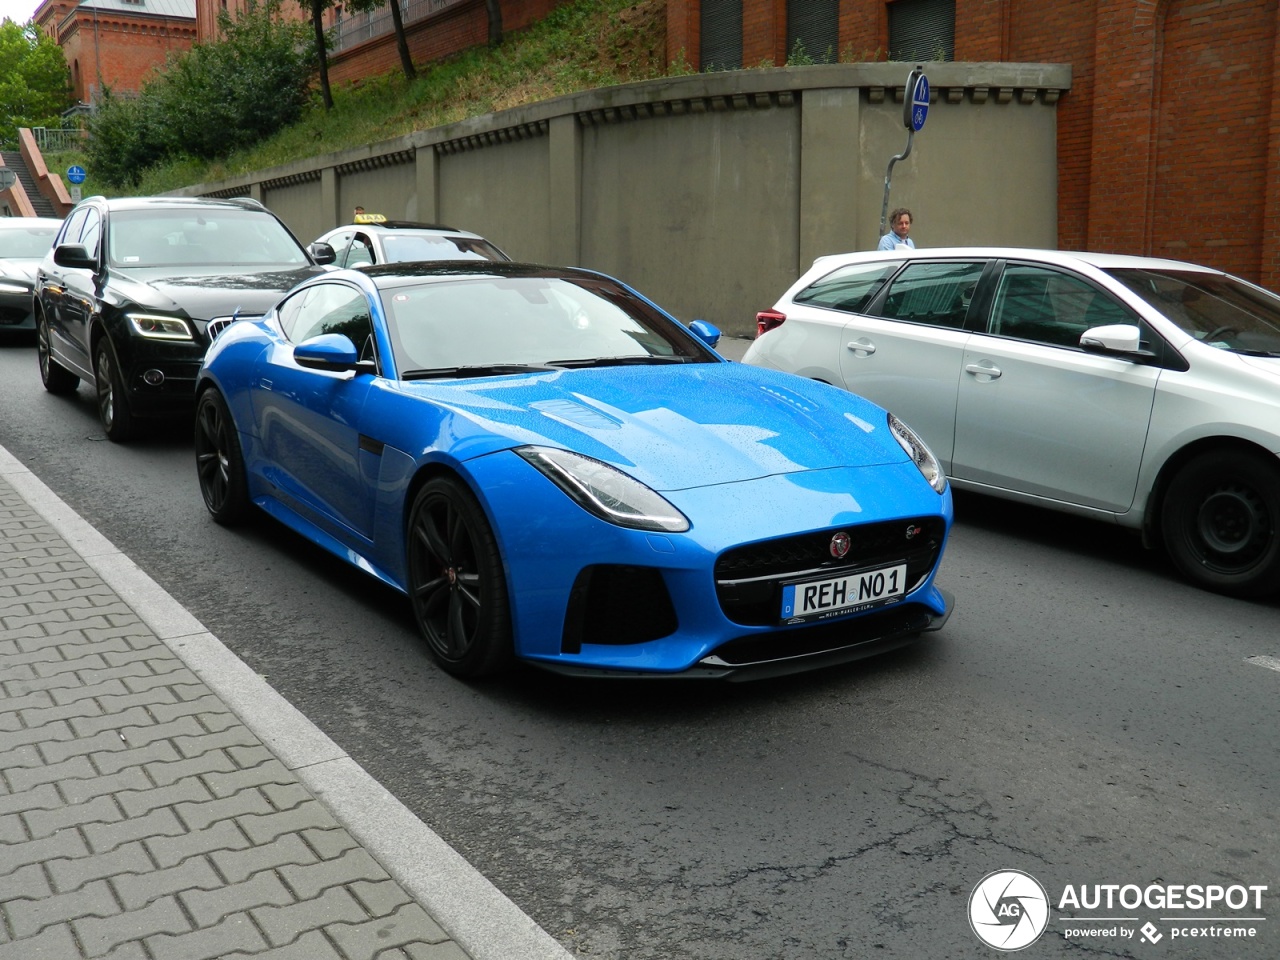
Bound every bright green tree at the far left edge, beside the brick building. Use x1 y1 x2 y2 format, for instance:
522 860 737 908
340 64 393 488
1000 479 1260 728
0 20 72 143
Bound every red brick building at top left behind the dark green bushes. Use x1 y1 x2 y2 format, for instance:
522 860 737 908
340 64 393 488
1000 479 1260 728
32 0 196 102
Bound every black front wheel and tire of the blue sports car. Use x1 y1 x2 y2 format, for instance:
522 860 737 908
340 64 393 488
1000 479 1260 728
407 477 513 678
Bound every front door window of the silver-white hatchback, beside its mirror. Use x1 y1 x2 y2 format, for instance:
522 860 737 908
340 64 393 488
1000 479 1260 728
991 264 1138 347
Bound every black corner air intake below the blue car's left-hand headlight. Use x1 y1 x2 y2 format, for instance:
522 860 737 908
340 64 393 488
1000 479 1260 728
561 563 677 653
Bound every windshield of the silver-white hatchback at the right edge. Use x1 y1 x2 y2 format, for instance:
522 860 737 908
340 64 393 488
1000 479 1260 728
1107 269 1280 356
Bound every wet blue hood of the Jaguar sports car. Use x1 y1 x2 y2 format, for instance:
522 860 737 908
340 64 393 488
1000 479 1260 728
401 364 906 490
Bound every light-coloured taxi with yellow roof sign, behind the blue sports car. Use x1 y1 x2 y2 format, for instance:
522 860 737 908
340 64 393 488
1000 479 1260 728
311 218 511 268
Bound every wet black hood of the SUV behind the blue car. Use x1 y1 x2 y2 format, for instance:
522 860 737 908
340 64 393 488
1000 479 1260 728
108 266 324 320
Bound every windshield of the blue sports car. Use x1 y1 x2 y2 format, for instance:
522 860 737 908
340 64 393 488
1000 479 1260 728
381 276 717 379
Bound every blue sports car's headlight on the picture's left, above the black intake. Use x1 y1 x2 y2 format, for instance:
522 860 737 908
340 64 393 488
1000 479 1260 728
516 447 689 534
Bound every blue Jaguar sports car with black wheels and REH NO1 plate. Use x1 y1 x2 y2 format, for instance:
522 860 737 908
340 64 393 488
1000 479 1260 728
196 261 951 678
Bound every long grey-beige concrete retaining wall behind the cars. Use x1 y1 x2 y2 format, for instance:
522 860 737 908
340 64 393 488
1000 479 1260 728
172 63 1071 335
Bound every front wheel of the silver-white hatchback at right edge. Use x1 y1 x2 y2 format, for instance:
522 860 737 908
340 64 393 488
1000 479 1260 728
1161 451 1280 596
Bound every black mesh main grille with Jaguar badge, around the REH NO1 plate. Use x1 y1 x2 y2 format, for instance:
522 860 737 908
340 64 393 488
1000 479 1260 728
716 517 946 626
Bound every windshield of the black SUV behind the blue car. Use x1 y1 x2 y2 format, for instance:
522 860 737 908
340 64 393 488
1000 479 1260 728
108 207 310 269
